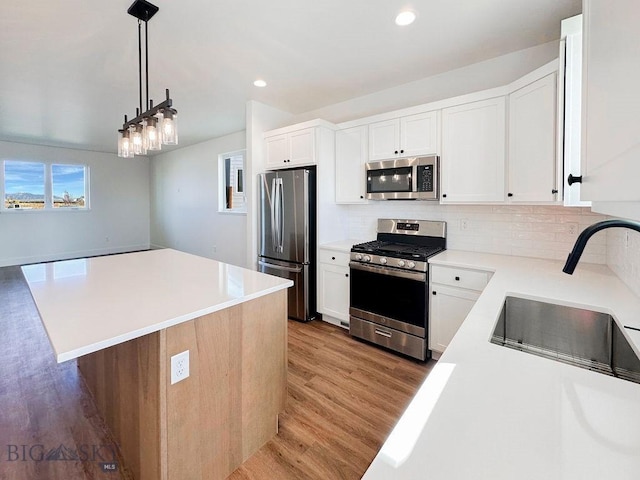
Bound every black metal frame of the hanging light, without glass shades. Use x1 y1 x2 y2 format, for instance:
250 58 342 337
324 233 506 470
122 0 173 130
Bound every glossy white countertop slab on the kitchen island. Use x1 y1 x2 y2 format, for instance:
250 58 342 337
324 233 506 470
22 249 293 362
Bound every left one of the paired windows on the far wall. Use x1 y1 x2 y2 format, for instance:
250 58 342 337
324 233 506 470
4 160 45 210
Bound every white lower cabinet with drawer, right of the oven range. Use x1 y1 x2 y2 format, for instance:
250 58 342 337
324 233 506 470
429 265 491 354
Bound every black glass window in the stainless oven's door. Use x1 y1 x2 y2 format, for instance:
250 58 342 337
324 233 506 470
349 268 428 328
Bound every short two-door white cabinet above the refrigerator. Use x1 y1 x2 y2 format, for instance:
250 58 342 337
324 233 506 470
265 127 318 169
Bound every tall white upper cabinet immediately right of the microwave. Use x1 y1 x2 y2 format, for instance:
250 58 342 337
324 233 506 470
440 97 506 203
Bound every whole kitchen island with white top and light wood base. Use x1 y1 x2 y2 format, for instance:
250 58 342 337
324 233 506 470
23 249 292 480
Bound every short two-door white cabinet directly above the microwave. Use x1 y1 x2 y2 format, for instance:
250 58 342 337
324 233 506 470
369 111 438 161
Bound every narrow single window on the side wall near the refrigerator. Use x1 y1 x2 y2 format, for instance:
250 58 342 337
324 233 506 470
218 150 247 213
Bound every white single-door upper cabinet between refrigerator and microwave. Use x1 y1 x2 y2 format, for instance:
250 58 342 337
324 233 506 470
336 125 368 203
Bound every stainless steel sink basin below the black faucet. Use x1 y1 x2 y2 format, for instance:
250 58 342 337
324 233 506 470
491 297 640 383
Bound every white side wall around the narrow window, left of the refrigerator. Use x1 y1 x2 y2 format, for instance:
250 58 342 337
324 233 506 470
151 132 247 266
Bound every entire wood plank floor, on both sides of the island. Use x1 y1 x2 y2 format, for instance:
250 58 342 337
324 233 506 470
0 267 434 480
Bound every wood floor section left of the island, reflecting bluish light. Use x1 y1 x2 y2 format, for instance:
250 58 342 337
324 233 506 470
0 267 130 480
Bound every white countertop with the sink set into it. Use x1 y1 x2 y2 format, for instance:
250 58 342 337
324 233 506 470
364 250 640 480
